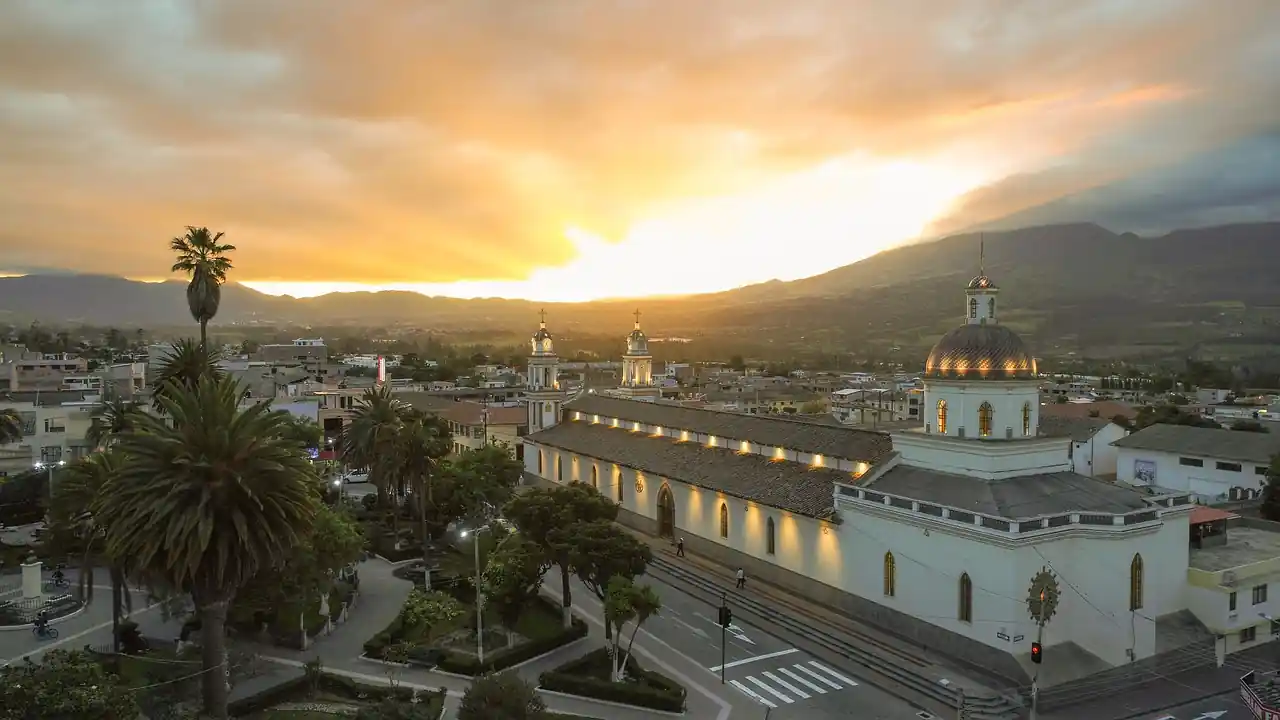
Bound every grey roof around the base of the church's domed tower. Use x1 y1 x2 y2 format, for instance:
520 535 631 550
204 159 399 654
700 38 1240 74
868 465 1149 520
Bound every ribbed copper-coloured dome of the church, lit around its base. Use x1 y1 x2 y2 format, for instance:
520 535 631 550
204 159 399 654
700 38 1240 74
924 324 1036 380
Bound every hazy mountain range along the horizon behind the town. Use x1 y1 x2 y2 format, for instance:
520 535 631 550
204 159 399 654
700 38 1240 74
0 223 1280 355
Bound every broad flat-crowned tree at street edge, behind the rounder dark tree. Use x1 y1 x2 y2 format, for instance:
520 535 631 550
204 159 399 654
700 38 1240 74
504 483 618 628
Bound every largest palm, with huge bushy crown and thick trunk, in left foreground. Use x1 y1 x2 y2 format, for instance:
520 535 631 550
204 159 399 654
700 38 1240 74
96 377 321 717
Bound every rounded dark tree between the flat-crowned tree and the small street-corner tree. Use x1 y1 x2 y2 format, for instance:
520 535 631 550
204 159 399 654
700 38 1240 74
568 520 653 639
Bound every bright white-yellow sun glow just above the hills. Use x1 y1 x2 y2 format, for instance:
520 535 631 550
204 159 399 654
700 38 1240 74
244 155 992 302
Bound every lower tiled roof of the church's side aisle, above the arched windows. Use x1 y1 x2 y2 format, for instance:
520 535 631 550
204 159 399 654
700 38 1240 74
526 420 852 518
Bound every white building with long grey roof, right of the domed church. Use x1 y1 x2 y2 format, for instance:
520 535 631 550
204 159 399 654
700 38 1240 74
1112 424 1280 502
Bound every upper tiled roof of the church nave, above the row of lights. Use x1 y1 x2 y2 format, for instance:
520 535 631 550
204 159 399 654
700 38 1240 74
568 393 893 464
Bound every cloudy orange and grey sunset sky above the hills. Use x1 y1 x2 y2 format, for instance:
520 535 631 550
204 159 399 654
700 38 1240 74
0 0 1280 301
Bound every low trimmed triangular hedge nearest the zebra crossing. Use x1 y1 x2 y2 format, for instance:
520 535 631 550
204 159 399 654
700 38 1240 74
539 647 685 712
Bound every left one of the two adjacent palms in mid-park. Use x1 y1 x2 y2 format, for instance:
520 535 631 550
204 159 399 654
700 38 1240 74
340 386 408 520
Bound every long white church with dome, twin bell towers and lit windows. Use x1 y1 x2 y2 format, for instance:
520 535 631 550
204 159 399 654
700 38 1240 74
525 274 1193 678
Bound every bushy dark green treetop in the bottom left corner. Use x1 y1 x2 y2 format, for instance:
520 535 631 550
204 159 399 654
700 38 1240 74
0 650 138 720
